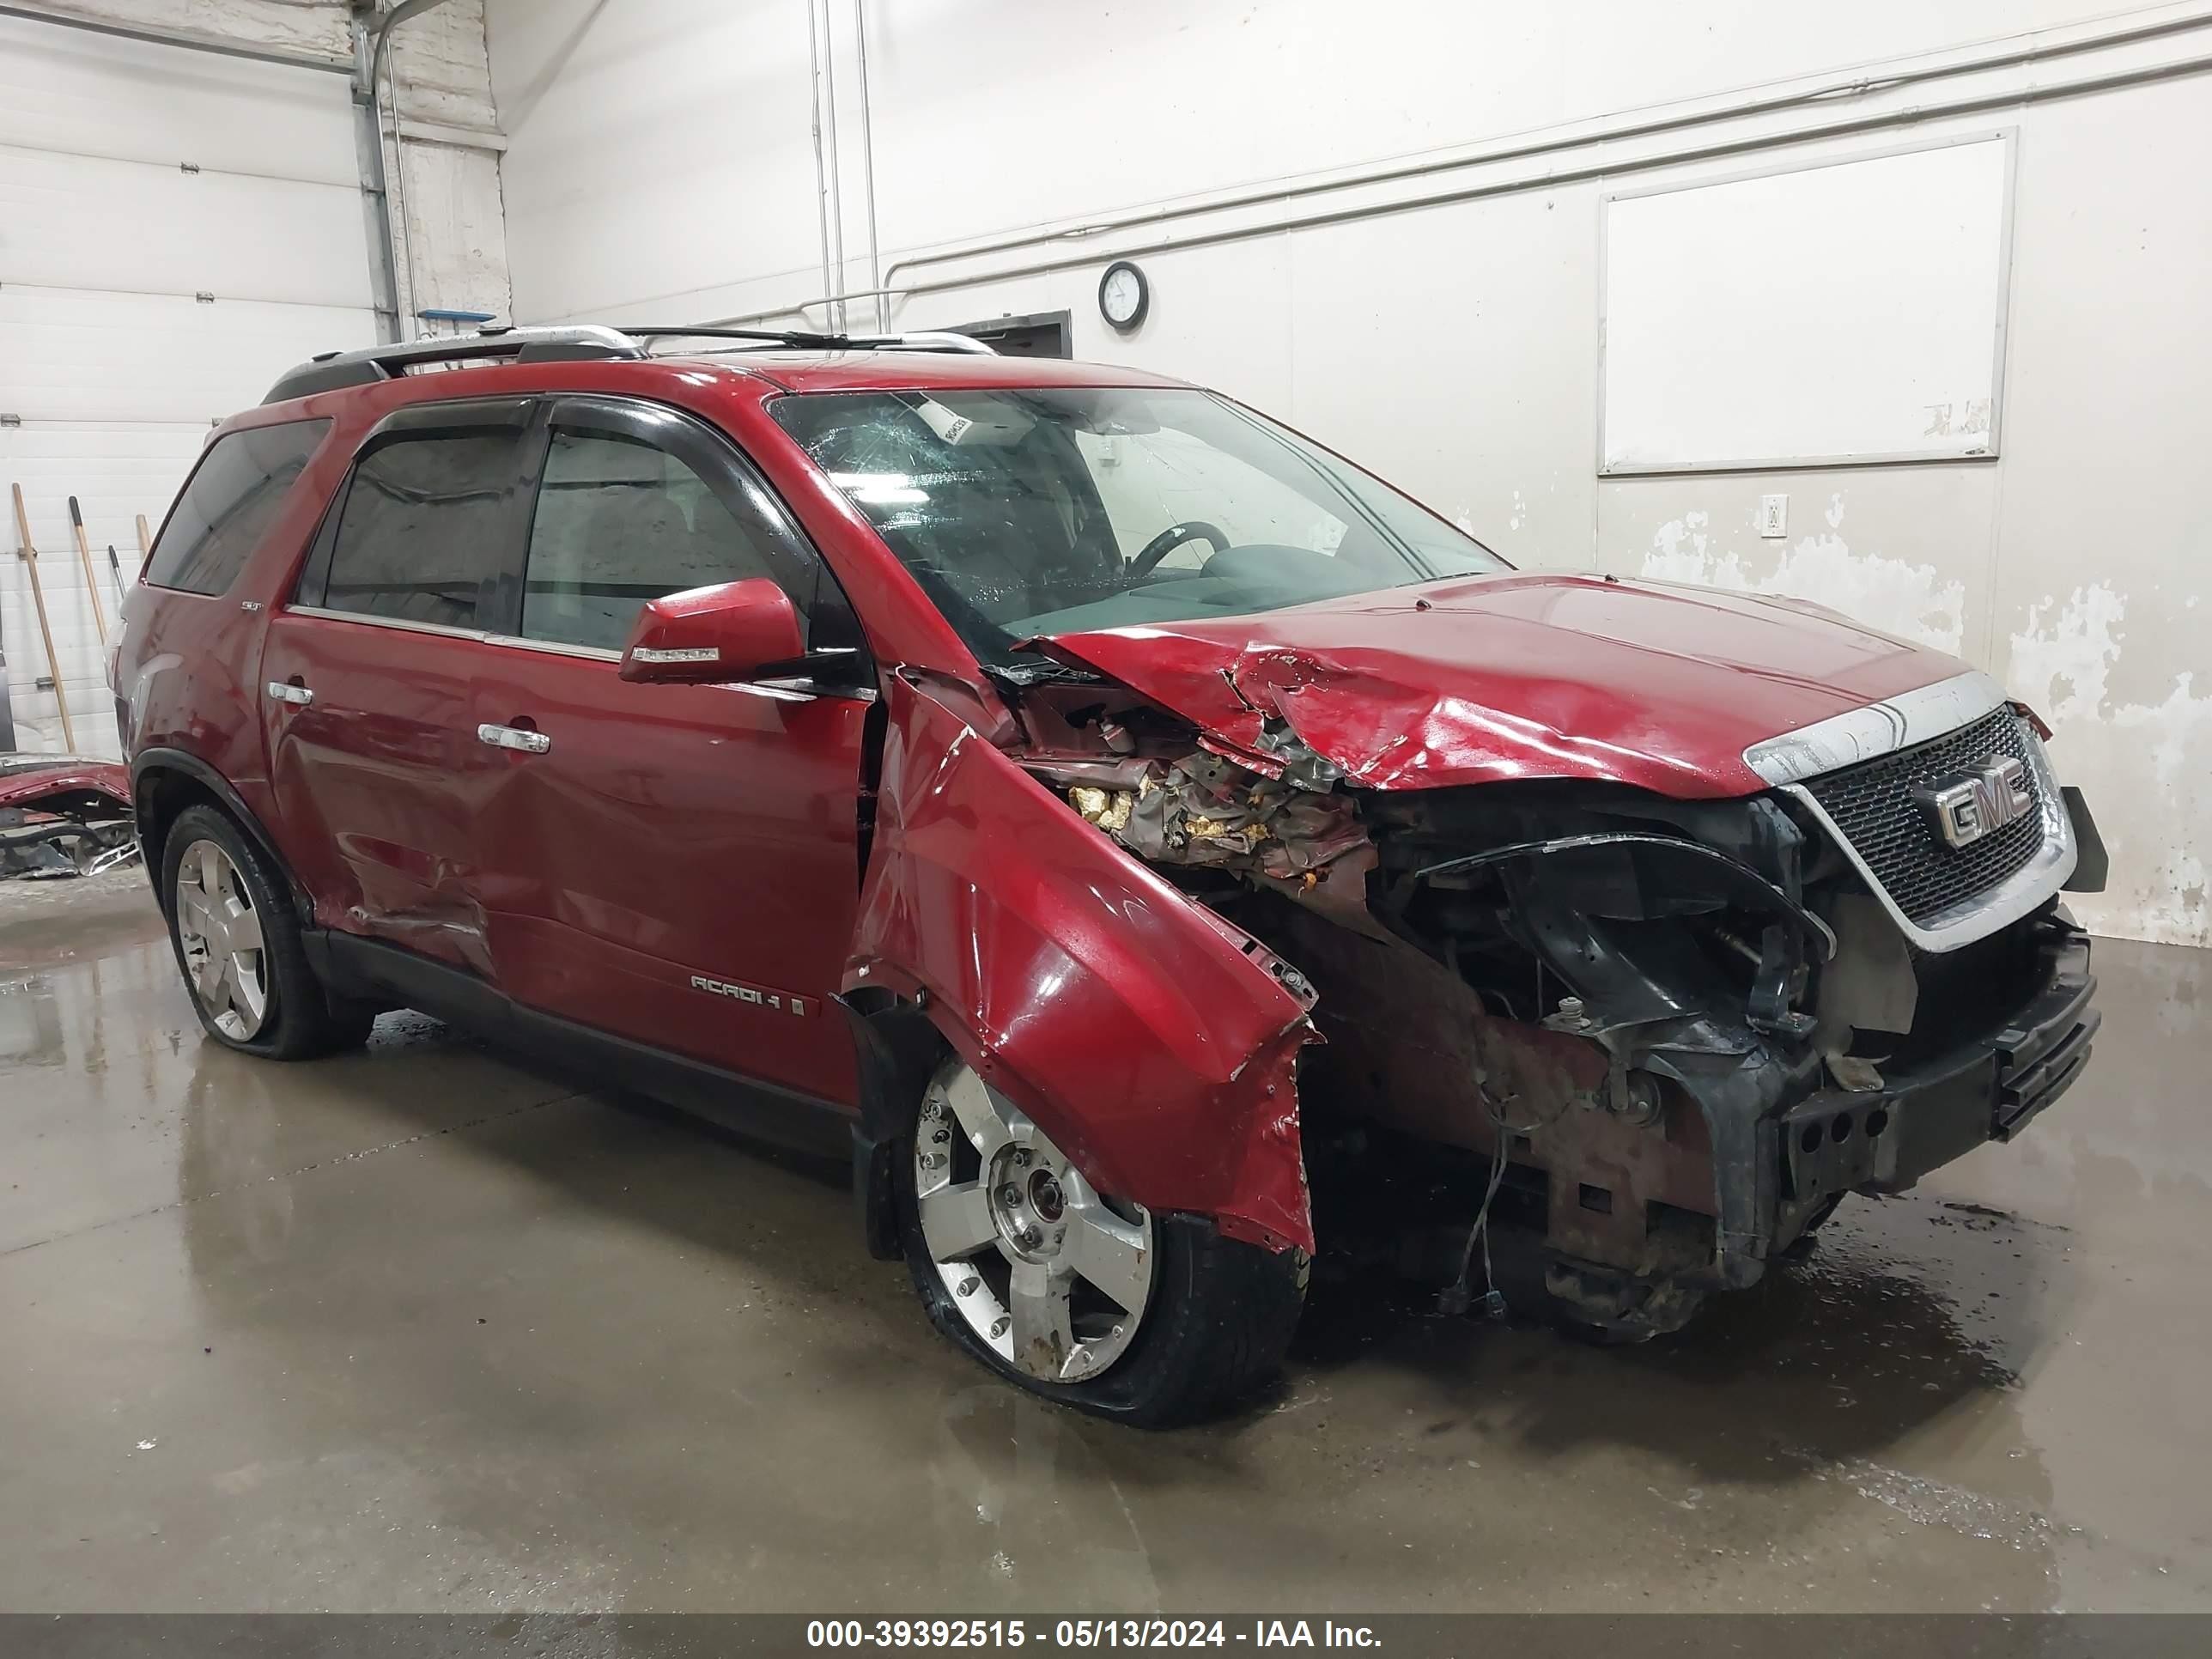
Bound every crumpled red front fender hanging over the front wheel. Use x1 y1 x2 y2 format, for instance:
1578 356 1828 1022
845 675 1316 1249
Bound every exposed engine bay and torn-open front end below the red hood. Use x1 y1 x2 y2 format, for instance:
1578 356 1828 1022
1015 675 2097 1338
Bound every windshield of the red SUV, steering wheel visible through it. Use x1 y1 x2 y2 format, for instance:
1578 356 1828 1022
772 387 1506 665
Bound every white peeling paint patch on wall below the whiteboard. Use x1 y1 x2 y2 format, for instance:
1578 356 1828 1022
1641 513 1966 653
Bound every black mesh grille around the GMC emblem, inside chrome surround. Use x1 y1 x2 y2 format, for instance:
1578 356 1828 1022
1805 706 2044 925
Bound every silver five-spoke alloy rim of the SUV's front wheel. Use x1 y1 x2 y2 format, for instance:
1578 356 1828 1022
914 1061 1155 1382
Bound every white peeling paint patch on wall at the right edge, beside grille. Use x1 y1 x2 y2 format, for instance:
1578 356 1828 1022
2004 581 2212 945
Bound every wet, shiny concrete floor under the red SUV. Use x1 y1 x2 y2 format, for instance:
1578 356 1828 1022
0 872 2212 1613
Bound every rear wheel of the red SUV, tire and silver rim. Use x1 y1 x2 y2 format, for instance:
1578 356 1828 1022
161 805 376 1060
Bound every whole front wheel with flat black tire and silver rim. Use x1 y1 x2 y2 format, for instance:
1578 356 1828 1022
891 1060 1307 1429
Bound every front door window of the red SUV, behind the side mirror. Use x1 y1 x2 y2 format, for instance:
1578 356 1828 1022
522 427 807 650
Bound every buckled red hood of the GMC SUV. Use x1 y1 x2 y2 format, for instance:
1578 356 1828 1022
1036 573 1964 799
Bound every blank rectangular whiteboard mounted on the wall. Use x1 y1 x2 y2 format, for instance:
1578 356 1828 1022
1599 133 2013 473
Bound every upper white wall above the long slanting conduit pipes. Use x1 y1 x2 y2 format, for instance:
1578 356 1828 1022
497 0 2141 319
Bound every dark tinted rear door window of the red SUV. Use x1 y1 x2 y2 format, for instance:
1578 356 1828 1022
323 431 520 629
